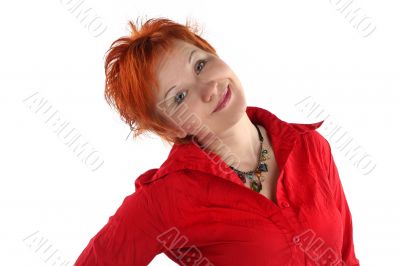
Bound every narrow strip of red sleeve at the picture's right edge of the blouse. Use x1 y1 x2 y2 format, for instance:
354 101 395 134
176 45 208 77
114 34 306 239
318 133 360 266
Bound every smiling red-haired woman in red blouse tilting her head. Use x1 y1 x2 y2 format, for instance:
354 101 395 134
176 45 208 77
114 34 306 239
75 18 359 266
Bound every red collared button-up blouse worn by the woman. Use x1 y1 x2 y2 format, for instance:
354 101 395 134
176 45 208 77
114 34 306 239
75 106 360 266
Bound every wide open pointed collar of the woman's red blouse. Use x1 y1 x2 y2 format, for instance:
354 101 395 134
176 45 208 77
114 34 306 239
135 106 324 190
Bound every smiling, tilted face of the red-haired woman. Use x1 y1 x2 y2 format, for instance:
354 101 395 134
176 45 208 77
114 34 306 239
156 40 246 142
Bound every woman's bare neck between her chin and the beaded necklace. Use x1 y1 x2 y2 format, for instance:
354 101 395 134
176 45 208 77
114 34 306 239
199 114 260 172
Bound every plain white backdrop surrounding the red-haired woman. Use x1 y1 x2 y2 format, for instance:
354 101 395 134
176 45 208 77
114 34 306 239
0 0 400 266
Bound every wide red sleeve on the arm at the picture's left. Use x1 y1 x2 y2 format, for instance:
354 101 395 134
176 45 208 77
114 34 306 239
74 191 166 266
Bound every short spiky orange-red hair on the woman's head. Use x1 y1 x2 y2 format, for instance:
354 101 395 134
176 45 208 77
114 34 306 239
104 18 216 144
